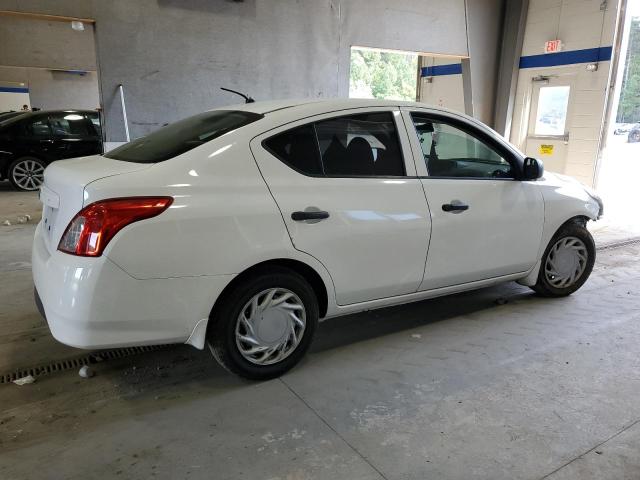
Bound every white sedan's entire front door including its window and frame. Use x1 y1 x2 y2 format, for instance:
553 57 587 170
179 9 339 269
403 109 544 290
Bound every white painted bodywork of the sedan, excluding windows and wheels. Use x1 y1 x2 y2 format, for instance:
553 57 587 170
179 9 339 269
32 100 599 348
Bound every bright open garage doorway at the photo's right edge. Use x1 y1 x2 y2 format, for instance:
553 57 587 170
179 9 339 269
596 0 640 236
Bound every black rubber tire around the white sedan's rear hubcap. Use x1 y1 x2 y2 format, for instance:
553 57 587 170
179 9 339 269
207 266 319 380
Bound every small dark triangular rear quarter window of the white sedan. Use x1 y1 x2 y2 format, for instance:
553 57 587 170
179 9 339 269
264 125 322 175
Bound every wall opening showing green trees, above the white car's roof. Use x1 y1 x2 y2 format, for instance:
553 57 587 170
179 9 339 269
349 47 418 101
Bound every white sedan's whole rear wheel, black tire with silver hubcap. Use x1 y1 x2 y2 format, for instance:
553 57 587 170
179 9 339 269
207 267 318 380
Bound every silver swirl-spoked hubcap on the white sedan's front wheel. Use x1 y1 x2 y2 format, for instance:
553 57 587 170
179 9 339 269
544 237 589 288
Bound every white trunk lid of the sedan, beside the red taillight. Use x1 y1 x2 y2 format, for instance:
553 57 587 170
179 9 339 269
40 155 152 253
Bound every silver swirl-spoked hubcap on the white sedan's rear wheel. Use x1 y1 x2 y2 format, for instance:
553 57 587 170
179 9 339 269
236 288 307 365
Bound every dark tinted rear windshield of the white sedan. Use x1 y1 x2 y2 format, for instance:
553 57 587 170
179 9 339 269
104 110 262 163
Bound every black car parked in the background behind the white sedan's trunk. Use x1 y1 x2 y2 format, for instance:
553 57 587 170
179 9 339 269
0 110 102 190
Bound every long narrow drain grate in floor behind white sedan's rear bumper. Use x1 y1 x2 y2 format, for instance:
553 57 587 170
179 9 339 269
0 345 173 384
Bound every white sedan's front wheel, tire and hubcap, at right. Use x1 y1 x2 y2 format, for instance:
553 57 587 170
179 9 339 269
531 223 596 297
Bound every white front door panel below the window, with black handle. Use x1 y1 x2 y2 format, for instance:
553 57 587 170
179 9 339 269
420 178 544 290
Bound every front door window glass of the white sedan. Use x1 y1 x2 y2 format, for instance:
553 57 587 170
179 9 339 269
411 113 515 178
